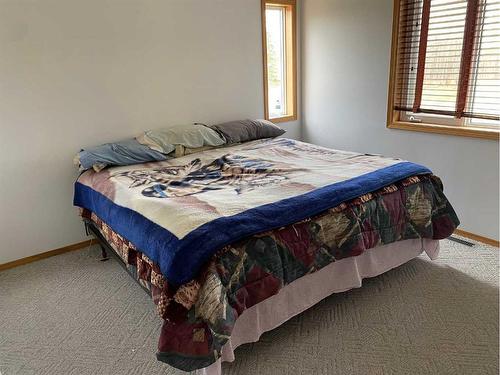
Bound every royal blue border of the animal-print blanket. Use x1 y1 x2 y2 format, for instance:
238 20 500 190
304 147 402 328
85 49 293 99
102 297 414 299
73 162 431 285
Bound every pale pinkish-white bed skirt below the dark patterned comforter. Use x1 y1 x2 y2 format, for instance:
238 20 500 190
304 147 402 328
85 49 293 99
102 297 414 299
195 239 439 375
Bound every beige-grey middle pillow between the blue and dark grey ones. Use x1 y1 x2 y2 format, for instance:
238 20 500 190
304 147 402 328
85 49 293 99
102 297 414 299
137 124 226 154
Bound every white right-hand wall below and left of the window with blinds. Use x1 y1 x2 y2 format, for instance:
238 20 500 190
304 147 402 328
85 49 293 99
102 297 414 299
301 0 499 240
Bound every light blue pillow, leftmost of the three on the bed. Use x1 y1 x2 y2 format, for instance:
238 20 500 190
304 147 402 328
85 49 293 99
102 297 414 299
74 138 171 172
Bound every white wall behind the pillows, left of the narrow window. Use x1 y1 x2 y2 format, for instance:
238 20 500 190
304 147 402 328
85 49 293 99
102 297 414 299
0 0 300 264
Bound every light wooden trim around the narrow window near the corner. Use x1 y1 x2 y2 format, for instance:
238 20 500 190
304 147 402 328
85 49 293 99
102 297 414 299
261 0 297 122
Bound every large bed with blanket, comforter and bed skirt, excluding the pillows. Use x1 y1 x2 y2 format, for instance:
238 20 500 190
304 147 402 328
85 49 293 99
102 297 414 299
74 138 459 375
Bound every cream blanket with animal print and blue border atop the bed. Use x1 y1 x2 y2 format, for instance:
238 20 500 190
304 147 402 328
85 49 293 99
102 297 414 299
74 139 430 285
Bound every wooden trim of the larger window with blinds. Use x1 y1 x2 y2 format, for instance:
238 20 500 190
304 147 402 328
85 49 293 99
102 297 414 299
387 0 500 141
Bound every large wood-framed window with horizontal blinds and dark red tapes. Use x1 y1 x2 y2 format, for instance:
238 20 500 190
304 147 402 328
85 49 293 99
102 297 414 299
388 0 500 139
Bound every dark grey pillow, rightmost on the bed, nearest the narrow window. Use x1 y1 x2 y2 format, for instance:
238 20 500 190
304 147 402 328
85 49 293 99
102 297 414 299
210 120 286 144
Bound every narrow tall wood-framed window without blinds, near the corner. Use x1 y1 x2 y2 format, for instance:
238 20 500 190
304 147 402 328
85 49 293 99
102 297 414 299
262 0 297 122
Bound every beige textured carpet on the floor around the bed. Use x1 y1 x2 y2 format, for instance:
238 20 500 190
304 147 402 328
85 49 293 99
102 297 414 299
0 240 499 375
